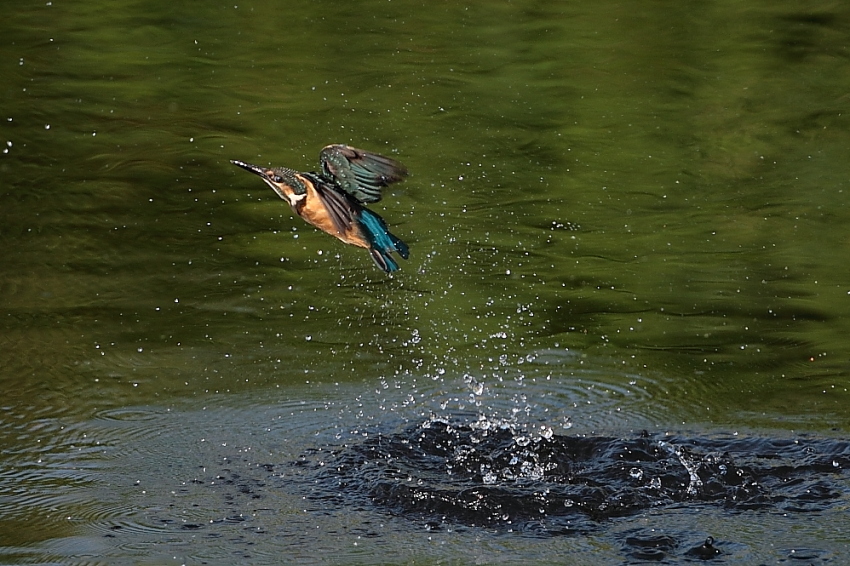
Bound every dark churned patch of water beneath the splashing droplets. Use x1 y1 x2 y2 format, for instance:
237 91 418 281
296 419 850 534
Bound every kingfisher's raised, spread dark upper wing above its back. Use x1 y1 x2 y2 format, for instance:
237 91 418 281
319 144 407 204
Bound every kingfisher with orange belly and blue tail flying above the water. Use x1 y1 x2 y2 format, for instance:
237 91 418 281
230 144 410 273
